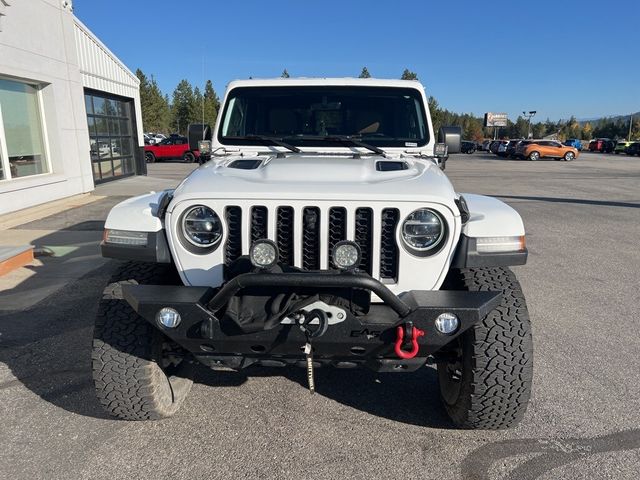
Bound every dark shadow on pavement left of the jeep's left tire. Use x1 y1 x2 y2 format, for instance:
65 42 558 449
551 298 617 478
0 262 114 418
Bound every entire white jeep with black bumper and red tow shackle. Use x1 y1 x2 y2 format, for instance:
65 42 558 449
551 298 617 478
92 78 533 429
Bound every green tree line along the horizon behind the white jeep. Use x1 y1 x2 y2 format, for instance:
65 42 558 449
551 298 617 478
136 66 640 141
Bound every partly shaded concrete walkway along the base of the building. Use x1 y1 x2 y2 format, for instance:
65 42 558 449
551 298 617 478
0 164 194 312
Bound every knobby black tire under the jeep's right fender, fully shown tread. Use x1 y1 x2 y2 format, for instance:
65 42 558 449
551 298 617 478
438 268 533 429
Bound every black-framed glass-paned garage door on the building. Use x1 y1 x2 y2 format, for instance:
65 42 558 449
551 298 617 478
84 92 134 182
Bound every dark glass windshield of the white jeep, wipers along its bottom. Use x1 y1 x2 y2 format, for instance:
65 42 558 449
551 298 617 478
218 86 429 147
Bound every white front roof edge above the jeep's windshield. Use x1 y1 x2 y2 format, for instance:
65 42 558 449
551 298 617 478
227 77 422 90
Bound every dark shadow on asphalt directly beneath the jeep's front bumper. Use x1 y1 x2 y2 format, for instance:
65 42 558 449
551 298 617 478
194 360 454 429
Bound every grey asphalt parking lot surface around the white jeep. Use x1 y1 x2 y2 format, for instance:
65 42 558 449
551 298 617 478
0 153 640 480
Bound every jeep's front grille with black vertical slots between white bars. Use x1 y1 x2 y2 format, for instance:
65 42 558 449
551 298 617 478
224 205 400 283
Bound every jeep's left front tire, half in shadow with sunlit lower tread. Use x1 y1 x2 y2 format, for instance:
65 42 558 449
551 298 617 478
91 262 192 420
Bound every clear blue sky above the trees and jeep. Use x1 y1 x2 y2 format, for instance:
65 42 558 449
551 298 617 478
74 0 640 121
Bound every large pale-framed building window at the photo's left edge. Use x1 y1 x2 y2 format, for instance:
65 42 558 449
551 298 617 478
0 78 49 180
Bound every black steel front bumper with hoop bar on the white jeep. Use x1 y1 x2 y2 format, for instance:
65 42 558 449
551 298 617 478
123 272 501 371
